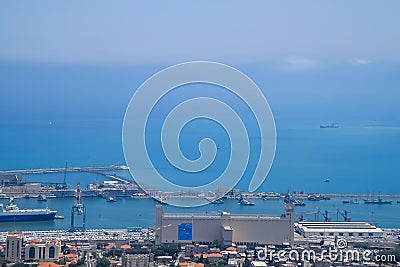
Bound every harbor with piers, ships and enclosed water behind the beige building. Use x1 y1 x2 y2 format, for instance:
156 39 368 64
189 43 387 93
0 165 400 231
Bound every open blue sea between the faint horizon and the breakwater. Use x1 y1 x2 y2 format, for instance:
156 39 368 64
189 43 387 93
0 119 400 194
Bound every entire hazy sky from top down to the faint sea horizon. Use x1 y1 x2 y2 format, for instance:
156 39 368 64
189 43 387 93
0 0 400 122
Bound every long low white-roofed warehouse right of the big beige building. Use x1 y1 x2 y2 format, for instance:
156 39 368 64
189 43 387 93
295 222 383 237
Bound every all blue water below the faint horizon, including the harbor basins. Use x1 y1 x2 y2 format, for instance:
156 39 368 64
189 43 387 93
0 120 400 231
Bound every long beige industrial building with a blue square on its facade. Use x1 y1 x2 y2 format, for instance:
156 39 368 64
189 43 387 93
156 204 294 246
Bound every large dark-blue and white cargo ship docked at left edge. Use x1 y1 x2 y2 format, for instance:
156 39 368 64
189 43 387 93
0 200 57 222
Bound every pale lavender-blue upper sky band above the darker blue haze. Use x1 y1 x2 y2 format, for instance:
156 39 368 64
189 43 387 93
0 0 400 65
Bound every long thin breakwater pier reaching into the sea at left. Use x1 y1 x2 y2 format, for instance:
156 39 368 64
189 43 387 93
0 165 132 184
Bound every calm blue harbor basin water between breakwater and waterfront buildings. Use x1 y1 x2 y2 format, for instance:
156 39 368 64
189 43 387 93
0 198 400 231
